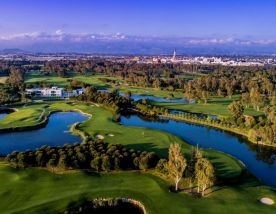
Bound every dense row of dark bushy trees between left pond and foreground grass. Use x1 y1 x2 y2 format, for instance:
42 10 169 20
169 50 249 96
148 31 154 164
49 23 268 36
6 141 159 172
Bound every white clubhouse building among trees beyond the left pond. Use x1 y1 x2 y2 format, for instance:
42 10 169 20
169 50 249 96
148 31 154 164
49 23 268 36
26 87 85 98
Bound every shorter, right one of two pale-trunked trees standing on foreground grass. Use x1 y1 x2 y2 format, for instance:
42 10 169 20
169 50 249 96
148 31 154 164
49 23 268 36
195 158 215 196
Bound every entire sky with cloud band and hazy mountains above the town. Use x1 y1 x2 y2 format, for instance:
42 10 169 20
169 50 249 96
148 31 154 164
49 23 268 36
0 0 276 54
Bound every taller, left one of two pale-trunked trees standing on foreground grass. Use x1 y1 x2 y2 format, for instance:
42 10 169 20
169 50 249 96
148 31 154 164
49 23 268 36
167 143 187 191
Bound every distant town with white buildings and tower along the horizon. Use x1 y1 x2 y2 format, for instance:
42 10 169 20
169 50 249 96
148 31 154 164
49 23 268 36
0 50 276 66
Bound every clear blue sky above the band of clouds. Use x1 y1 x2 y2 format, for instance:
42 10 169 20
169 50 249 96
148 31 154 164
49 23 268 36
0 0 276 39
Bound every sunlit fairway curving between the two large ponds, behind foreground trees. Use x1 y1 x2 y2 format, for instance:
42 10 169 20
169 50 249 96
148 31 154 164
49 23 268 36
0 101 243 177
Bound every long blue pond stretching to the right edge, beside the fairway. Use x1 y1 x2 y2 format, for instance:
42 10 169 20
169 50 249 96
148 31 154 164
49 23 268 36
121 115 276 186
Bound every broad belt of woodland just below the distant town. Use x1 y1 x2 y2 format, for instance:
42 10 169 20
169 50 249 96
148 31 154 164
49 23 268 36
22 58 276 109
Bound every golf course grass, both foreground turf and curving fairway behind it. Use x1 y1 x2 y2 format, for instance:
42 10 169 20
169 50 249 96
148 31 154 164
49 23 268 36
0 101 276 214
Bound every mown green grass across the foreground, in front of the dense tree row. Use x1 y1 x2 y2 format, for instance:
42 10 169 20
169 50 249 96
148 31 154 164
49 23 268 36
0 165 276 214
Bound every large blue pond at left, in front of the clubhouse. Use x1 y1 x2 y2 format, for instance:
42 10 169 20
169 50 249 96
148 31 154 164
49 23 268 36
0 112 88 154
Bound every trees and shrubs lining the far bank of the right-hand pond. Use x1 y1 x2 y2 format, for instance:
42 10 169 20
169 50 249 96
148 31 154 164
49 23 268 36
165 101 276 145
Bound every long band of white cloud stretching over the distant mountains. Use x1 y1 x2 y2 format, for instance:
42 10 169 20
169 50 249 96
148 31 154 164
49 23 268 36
0 29 276 45
